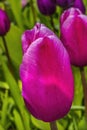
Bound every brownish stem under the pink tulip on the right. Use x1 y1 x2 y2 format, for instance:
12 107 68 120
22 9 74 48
80 67 87 120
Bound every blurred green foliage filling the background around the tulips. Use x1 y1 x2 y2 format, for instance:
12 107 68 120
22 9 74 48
0 0 87 130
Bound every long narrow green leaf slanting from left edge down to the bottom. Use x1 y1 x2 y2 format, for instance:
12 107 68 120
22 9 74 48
0 56 30 130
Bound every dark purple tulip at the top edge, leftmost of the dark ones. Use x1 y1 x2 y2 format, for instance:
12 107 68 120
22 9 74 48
37 0 56 15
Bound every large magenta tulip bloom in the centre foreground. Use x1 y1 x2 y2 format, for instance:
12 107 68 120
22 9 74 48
20 23 74 122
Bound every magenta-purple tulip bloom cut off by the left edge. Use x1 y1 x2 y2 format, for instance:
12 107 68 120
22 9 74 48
0 9 10 36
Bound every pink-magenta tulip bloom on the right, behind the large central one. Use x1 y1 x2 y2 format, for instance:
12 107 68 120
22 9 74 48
60 8 87 66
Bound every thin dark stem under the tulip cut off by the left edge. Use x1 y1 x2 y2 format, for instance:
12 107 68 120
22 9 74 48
2 37 14 79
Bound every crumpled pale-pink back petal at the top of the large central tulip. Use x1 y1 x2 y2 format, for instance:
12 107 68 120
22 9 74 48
22 23 54 53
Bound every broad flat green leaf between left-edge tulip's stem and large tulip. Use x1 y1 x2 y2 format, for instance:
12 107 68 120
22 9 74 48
6 24 22 67
